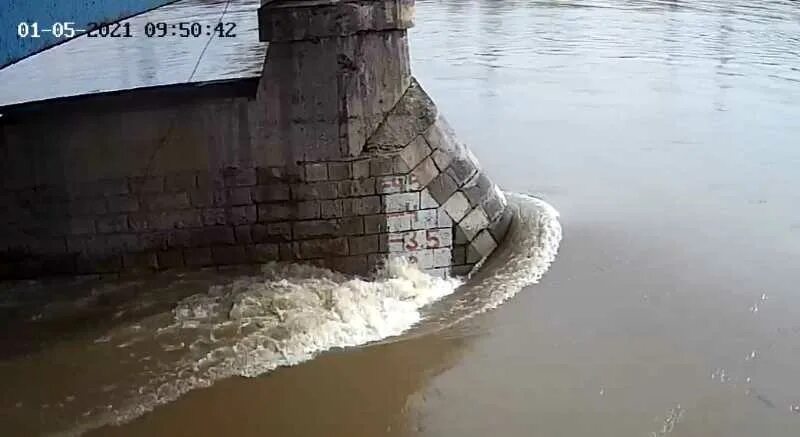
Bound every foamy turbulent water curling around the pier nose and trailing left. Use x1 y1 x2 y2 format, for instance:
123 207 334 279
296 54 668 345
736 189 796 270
4 194 561 434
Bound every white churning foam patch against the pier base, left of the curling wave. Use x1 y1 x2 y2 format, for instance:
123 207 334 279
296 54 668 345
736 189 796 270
76 260 460 431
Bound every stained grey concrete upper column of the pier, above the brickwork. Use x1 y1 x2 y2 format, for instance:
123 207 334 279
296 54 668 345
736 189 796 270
259 0 414 162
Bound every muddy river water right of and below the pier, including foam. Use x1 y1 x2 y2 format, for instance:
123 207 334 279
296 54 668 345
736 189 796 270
0 0 800 437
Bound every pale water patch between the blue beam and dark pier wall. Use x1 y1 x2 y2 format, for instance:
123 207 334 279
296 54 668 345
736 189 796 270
0 0 267 113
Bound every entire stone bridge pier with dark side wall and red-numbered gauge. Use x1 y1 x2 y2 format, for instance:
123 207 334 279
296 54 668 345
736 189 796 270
0 0 511 277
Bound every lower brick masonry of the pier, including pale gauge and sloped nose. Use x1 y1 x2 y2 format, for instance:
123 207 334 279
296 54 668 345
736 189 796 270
0 81 510 277
